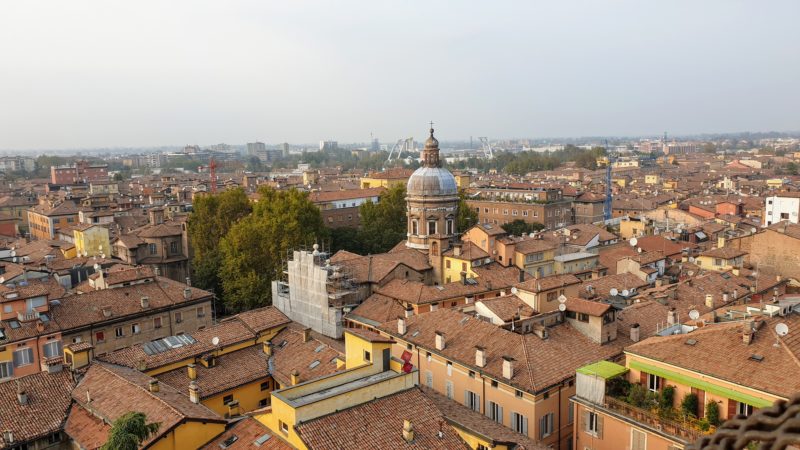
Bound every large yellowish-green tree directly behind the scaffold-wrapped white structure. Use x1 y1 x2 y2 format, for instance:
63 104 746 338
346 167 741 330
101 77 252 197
219 186 328 312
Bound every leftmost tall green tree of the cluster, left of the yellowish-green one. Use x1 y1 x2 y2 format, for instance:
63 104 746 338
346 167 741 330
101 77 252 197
188 189 252 294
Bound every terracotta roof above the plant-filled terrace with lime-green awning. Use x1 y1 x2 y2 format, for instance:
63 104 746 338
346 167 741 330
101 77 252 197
626 313 800 398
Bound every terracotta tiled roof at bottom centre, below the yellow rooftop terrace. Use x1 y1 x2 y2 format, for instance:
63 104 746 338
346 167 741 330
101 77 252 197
296 388 468 450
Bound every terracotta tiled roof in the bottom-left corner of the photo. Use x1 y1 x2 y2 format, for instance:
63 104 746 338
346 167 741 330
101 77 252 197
0 370 74 448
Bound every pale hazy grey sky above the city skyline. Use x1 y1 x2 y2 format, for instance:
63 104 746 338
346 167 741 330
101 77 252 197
0 0 800 149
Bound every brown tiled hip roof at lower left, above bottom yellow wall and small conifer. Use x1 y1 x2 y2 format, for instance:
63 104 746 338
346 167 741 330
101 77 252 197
72 362 225 444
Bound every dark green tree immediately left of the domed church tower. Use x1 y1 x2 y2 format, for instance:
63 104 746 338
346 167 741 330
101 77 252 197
358 184 407 254
